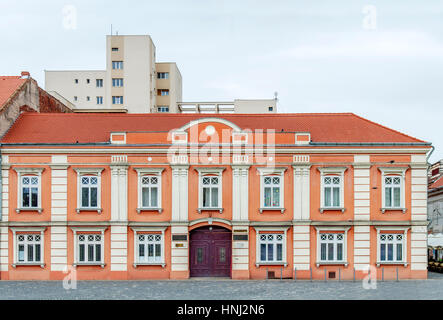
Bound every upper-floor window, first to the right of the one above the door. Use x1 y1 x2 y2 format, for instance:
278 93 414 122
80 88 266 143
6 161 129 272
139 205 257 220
257 168 286 213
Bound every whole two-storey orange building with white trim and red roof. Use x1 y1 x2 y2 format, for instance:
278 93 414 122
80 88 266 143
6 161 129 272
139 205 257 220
0 113 431 280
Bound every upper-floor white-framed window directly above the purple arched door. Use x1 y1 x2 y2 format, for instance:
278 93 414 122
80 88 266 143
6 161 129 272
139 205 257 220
196 168 225 212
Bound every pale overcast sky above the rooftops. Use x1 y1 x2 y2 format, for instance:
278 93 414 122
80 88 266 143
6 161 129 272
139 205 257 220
0 0 443 162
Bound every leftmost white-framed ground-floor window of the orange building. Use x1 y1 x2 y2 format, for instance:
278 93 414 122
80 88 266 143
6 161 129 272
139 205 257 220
16 234 43 264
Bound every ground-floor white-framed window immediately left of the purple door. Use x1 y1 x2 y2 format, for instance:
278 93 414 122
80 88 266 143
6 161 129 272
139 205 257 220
137 234 163 263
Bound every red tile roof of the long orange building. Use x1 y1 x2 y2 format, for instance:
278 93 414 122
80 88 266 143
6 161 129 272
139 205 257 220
1 113 430 143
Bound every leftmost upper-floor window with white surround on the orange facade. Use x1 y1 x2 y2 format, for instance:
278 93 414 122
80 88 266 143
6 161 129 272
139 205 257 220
14 168 44 213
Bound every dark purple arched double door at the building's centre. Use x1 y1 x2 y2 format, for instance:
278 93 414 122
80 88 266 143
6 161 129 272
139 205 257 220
189 226 232 277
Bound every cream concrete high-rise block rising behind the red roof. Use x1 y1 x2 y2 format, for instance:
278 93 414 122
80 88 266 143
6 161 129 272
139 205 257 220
45 35 182 113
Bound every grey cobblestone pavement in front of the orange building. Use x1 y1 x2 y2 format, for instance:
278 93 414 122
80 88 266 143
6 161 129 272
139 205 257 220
0 273 443 300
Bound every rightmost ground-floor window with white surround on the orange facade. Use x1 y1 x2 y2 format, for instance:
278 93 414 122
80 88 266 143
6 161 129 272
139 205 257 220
375 227 409 267
